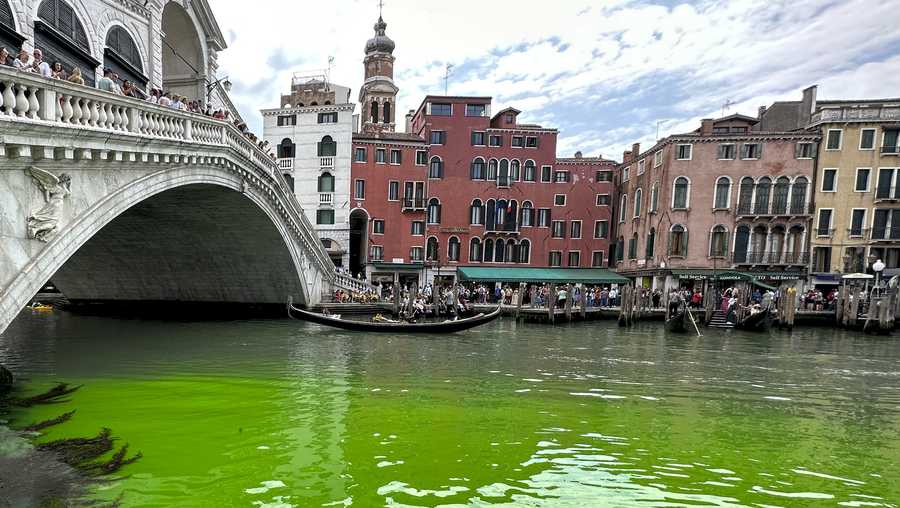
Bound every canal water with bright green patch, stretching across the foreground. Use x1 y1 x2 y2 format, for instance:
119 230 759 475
0 313 900 508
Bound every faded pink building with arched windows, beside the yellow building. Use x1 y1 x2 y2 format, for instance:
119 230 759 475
614 115 818 289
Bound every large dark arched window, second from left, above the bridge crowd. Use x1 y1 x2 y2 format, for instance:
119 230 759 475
34 0 100 86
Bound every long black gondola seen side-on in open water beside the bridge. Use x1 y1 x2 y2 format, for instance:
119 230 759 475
288 302 500 333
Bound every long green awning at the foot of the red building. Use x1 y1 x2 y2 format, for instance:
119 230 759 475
456 266 631 284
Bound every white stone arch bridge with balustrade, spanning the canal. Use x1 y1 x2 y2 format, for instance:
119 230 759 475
0 68 362 332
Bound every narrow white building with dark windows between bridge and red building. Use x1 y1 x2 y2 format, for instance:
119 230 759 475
262 75 356 267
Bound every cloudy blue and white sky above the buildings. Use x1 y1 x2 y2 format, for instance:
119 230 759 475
210 0 900 160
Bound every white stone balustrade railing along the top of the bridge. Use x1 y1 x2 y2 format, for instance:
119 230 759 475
0 67 338 289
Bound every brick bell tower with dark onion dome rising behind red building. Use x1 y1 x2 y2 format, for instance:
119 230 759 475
359 10 399 132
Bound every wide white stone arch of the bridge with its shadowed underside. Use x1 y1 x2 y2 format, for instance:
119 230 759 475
0 166 322 329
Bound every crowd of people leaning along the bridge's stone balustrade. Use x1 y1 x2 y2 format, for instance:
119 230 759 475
0 46 275 160
